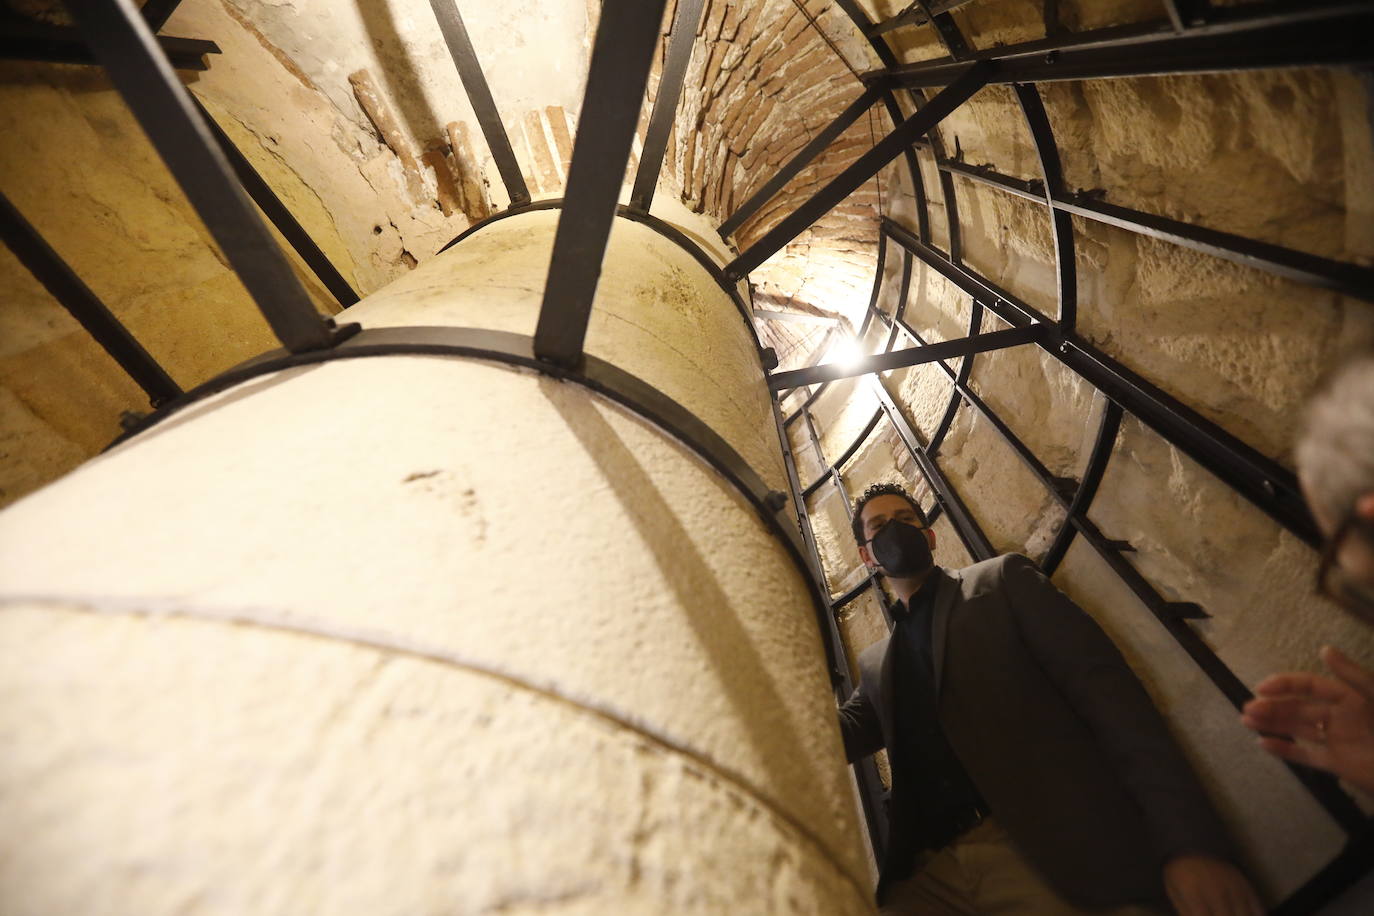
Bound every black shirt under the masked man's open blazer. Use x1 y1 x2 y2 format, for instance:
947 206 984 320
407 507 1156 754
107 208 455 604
888 570 987 873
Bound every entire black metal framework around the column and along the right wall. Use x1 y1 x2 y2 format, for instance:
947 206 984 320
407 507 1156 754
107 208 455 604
21 0 1374 916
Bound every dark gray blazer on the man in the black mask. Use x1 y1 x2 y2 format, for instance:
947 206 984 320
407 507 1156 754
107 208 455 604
840 555 1235 906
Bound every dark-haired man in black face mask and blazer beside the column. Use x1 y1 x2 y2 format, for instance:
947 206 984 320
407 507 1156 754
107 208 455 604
840 483 1263 916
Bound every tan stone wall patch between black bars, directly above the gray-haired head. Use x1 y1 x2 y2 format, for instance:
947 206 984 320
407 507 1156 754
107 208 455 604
1074 218 1374 460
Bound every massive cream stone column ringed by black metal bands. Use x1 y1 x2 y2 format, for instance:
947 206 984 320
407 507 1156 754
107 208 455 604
0 211 871 915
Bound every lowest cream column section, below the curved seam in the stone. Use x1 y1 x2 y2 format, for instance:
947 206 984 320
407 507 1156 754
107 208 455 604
0 602 868 915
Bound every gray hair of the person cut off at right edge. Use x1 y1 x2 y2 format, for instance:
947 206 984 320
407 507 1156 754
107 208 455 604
1296 354 1374 525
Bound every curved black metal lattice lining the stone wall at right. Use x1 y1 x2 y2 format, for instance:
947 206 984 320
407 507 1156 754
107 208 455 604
778 0 1374 916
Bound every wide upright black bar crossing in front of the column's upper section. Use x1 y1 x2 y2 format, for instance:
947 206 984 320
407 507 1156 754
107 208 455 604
534 0 666 367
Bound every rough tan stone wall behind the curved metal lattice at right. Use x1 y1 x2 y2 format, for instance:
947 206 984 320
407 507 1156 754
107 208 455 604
796 12 1374 901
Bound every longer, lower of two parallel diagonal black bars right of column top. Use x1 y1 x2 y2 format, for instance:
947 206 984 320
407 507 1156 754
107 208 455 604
725 62 992 280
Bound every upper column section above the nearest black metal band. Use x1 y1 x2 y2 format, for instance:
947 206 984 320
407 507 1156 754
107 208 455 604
341 210 787 490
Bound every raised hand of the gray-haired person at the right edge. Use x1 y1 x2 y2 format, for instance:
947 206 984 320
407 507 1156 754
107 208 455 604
1241 647 1374 792
